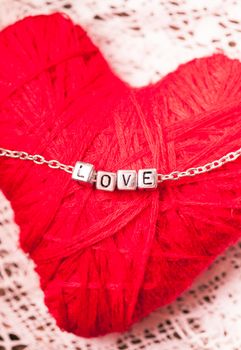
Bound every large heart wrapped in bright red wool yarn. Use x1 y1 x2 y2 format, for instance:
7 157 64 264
0 14 241 337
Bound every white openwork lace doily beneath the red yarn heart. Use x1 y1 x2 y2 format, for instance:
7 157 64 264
0 0 241 350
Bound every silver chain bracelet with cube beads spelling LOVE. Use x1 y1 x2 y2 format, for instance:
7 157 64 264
0 148 241 191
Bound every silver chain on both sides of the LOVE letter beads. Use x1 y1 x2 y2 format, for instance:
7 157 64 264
0 148 241 182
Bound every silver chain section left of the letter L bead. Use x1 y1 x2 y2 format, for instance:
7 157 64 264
0 148 74 174
